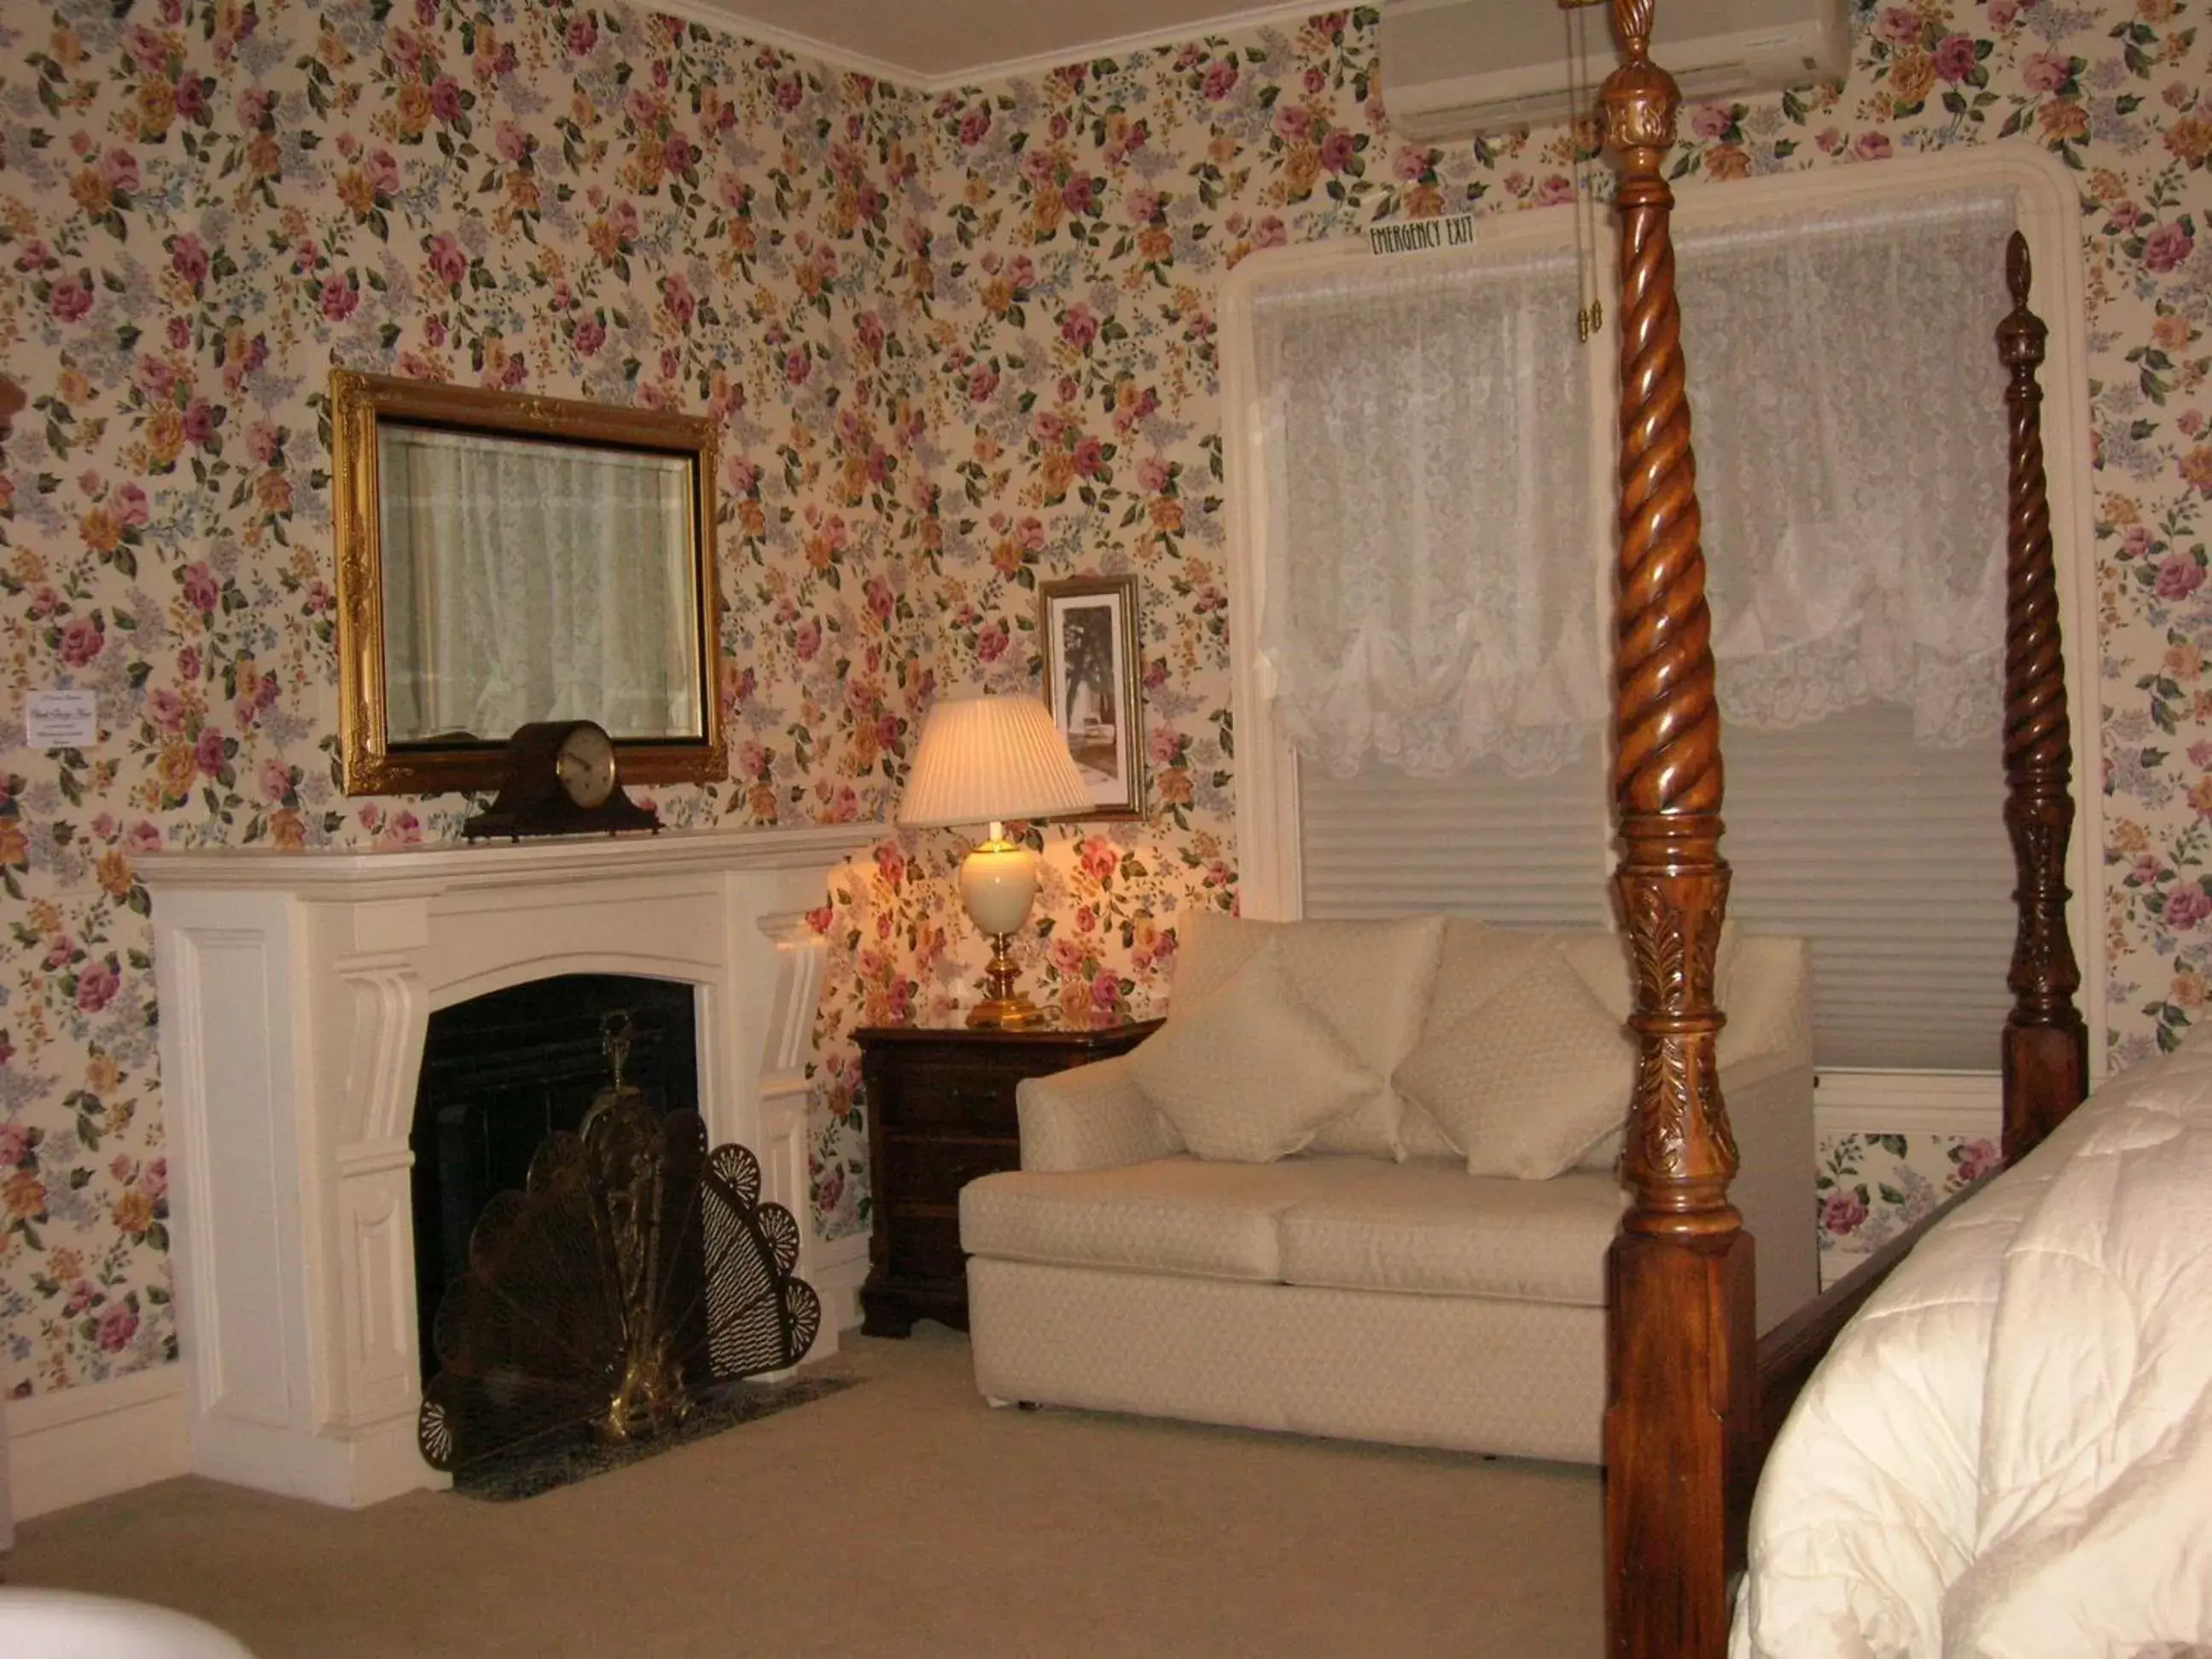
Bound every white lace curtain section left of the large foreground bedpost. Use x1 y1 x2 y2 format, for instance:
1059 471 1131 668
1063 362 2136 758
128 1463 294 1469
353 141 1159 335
1254 250 1606 774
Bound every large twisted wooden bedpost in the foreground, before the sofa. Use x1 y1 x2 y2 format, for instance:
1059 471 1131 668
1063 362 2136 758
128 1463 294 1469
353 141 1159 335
1599 0 1754 1659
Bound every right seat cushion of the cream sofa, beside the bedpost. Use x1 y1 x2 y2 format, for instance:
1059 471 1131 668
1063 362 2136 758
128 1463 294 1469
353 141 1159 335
1281 1159 1626 1307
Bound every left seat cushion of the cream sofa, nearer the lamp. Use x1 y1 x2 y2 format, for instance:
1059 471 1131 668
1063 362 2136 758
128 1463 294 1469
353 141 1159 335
960 1157 1388 1283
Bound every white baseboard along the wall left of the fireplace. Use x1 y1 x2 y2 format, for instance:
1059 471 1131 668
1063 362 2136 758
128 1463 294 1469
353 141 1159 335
7 1365 193 1522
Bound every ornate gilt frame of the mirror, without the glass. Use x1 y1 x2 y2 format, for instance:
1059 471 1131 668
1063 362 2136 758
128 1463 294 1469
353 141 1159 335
329 370 730 795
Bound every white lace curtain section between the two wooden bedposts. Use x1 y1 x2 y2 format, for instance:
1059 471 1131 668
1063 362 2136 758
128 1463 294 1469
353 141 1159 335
1677 190 2015 746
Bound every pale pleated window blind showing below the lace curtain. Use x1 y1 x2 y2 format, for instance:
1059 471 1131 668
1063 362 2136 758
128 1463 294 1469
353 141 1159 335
1299 703 2013 1071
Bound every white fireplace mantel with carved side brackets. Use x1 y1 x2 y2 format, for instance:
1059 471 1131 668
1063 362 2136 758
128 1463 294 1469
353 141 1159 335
135 825 876 1506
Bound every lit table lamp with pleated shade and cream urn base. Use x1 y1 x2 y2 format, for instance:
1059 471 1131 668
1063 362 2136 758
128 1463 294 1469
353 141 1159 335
898 696 1091 1031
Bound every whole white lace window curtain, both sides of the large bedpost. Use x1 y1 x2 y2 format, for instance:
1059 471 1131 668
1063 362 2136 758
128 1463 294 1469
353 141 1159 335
1254 190 2013 774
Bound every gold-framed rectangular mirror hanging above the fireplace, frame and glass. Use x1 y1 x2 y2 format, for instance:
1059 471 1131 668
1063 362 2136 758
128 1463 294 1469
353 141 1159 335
329 370 730 795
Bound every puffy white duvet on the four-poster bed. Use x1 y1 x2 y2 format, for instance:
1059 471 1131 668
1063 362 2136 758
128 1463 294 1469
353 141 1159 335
1730 1038 2212 1659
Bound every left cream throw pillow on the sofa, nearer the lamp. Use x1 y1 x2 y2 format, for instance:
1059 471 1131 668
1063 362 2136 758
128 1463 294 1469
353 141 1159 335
1128 940 1382 1163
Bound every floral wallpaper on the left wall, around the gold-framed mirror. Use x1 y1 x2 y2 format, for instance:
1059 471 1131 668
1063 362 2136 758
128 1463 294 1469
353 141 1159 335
0 0 934 1394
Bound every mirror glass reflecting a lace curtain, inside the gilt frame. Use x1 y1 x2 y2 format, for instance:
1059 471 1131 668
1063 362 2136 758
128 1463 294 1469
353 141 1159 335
378 427 699 741
